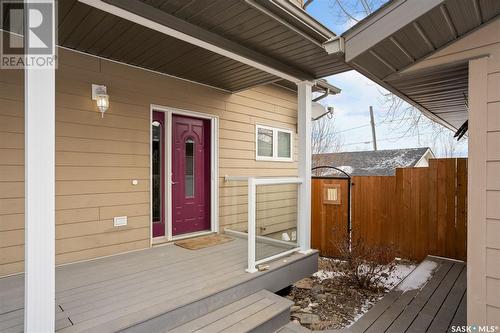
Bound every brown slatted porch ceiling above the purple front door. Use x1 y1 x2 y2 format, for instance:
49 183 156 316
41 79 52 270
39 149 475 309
52 0 350 91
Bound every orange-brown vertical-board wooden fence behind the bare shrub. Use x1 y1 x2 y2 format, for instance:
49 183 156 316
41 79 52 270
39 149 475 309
312 158 467 261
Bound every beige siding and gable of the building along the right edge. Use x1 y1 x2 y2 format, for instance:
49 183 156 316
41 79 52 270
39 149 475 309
404 19 500 326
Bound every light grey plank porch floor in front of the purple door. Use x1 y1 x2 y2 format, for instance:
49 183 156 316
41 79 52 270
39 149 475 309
0 238 317 332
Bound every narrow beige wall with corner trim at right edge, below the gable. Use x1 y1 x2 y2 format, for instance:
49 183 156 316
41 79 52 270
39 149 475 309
468 33 500 325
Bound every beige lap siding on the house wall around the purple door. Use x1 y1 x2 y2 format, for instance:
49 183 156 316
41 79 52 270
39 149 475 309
0 49 297 276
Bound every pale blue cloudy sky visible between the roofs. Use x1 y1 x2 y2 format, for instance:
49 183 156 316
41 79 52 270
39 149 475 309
307 0 467 156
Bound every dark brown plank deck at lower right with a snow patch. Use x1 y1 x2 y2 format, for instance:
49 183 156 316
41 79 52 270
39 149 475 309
342 257 467 333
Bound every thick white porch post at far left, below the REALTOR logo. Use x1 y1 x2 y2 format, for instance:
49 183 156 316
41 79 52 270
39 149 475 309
24 0 55 332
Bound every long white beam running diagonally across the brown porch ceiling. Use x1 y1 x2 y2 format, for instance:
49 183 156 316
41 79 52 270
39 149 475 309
78 0 304 83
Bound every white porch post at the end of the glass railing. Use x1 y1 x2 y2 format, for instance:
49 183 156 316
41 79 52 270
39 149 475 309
297 81 313 253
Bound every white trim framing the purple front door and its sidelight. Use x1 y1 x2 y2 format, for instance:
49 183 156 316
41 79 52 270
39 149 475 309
149 104 219 241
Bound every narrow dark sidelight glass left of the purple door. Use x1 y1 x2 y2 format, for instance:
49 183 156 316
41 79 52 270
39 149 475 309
152 121 162 222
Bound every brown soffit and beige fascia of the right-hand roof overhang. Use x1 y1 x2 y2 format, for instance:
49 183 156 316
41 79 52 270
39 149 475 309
344 0 500 129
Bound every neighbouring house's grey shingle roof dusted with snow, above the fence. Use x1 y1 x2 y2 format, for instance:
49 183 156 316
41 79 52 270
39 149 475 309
313 147 434 176
